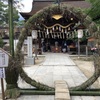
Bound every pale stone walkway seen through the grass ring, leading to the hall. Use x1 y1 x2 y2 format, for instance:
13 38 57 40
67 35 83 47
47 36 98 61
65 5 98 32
19 53 87 87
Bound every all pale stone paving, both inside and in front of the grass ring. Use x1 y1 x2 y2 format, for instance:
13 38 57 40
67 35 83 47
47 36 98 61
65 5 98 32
0 53 100 100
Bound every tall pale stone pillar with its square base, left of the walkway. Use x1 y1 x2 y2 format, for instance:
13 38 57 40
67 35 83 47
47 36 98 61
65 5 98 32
25 36 35 65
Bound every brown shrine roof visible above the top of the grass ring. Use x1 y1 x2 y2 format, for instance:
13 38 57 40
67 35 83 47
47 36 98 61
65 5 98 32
21 0 91 19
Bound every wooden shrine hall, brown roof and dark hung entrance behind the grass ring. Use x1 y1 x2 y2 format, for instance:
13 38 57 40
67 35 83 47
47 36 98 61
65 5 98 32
20 0 91 52
